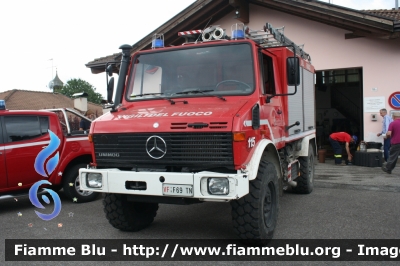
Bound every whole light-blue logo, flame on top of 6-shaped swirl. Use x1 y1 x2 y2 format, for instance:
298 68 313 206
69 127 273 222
29 129 61 221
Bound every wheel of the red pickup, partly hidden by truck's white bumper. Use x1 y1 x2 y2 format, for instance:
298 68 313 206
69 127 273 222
62 163 99 203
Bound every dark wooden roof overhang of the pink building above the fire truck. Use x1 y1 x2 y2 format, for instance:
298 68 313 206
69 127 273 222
86 0 400 74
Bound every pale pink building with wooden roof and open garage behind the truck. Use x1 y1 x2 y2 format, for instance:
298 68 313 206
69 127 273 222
87 0 400 148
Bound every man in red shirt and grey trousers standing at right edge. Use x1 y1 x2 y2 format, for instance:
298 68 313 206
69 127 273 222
382 112 400 174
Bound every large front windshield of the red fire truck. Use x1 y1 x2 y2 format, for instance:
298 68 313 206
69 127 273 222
126 43 254 101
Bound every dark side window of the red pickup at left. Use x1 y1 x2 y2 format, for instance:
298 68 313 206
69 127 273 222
4 116 49 142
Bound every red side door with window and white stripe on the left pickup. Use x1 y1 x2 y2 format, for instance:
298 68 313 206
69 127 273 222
3 115 50 189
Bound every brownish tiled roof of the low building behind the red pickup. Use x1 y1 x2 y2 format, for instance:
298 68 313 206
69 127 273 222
0 89 103 116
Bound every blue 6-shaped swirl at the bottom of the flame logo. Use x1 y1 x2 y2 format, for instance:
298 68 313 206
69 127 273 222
29 180 61 221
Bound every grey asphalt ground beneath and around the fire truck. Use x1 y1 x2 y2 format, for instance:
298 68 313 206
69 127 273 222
0 159 400 266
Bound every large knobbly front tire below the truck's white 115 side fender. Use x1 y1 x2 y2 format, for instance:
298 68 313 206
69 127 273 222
231 159 279 244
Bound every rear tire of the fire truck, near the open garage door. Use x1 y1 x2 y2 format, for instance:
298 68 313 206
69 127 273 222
293 144 315 194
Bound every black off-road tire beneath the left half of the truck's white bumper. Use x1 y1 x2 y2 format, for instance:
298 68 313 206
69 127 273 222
103 193 158 231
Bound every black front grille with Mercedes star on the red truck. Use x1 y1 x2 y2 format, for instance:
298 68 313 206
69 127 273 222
93 132 233 168
